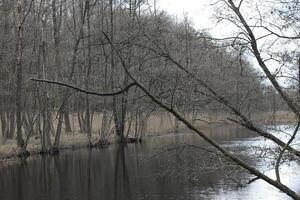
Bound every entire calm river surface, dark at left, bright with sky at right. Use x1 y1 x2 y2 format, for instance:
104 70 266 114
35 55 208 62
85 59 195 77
0 127 300 200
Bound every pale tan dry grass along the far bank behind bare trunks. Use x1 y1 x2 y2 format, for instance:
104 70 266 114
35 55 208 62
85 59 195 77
0 111 295 158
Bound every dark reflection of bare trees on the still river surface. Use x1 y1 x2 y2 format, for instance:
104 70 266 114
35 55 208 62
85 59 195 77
0 129 299 200
